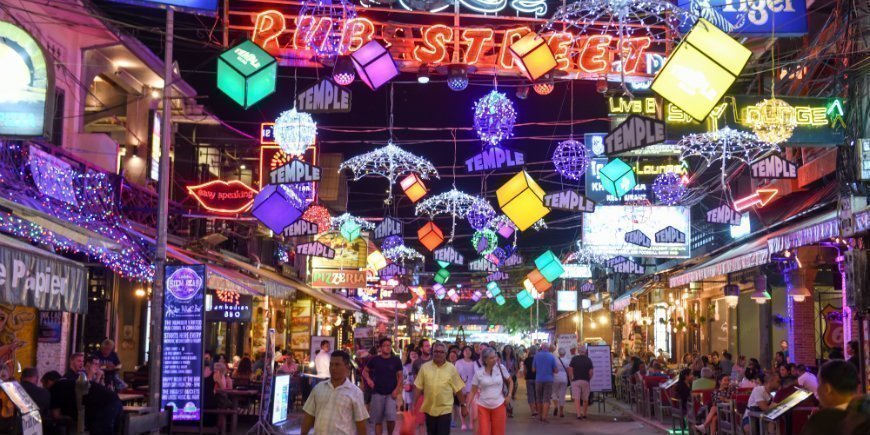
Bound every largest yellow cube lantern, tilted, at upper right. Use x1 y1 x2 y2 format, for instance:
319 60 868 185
650 18 752 121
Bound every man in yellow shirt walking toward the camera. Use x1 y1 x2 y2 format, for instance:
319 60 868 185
414 342 468 435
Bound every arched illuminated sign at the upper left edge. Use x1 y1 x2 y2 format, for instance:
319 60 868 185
0 21 54 136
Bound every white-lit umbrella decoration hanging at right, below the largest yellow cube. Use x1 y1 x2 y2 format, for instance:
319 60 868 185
677 127 779 188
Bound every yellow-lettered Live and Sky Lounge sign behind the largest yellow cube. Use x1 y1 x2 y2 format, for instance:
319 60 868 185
607 95 845 146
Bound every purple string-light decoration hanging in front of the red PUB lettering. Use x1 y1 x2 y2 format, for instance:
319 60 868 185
296 0 356 59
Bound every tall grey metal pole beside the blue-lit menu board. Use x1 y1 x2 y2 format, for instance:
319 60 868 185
148 6 175 412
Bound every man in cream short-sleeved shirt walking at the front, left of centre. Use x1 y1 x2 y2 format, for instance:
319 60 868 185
301 351 369 435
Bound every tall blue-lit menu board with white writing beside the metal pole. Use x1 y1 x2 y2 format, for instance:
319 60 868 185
160 264 206 421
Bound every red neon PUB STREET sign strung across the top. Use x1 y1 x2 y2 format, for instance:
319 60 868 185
230 6 665 81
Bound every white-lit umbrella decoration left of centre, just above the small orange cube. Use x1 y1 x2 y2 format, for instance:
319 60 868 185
338 142 439 204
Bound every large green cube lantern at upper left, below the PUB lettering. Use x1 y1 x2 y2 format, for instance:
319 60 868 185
217 41 278 109
